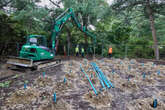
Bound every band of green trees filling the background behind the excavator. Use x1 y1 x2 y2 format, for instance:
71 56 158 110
0 0 165 59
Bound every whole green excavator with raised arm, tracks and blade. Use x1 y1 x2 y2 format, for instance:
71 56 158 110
7 8 96 69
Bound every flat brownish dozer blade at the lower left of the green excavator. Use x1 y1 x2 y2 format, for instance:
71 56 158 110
7 57 33 67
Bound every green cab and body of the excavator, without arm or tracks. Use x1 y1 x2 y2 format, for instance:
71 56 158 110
19 35 54 61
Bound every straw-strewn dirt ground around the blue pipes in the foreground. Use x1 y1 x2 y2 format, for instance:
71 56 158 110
0 58 165 110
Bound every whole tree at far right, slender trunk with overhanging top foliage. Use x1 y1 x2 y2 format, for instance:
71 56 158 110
113 0 165 60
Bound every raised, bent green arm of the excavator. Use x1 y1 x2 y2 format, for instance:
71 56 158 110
52 8 96 54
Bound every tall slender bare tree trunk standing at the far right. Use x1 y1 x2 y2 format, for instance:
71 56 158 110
147 0 159 60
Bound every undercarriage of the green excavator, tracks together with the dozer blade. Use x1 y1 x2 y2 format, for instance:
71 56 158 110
7 57 62 72
